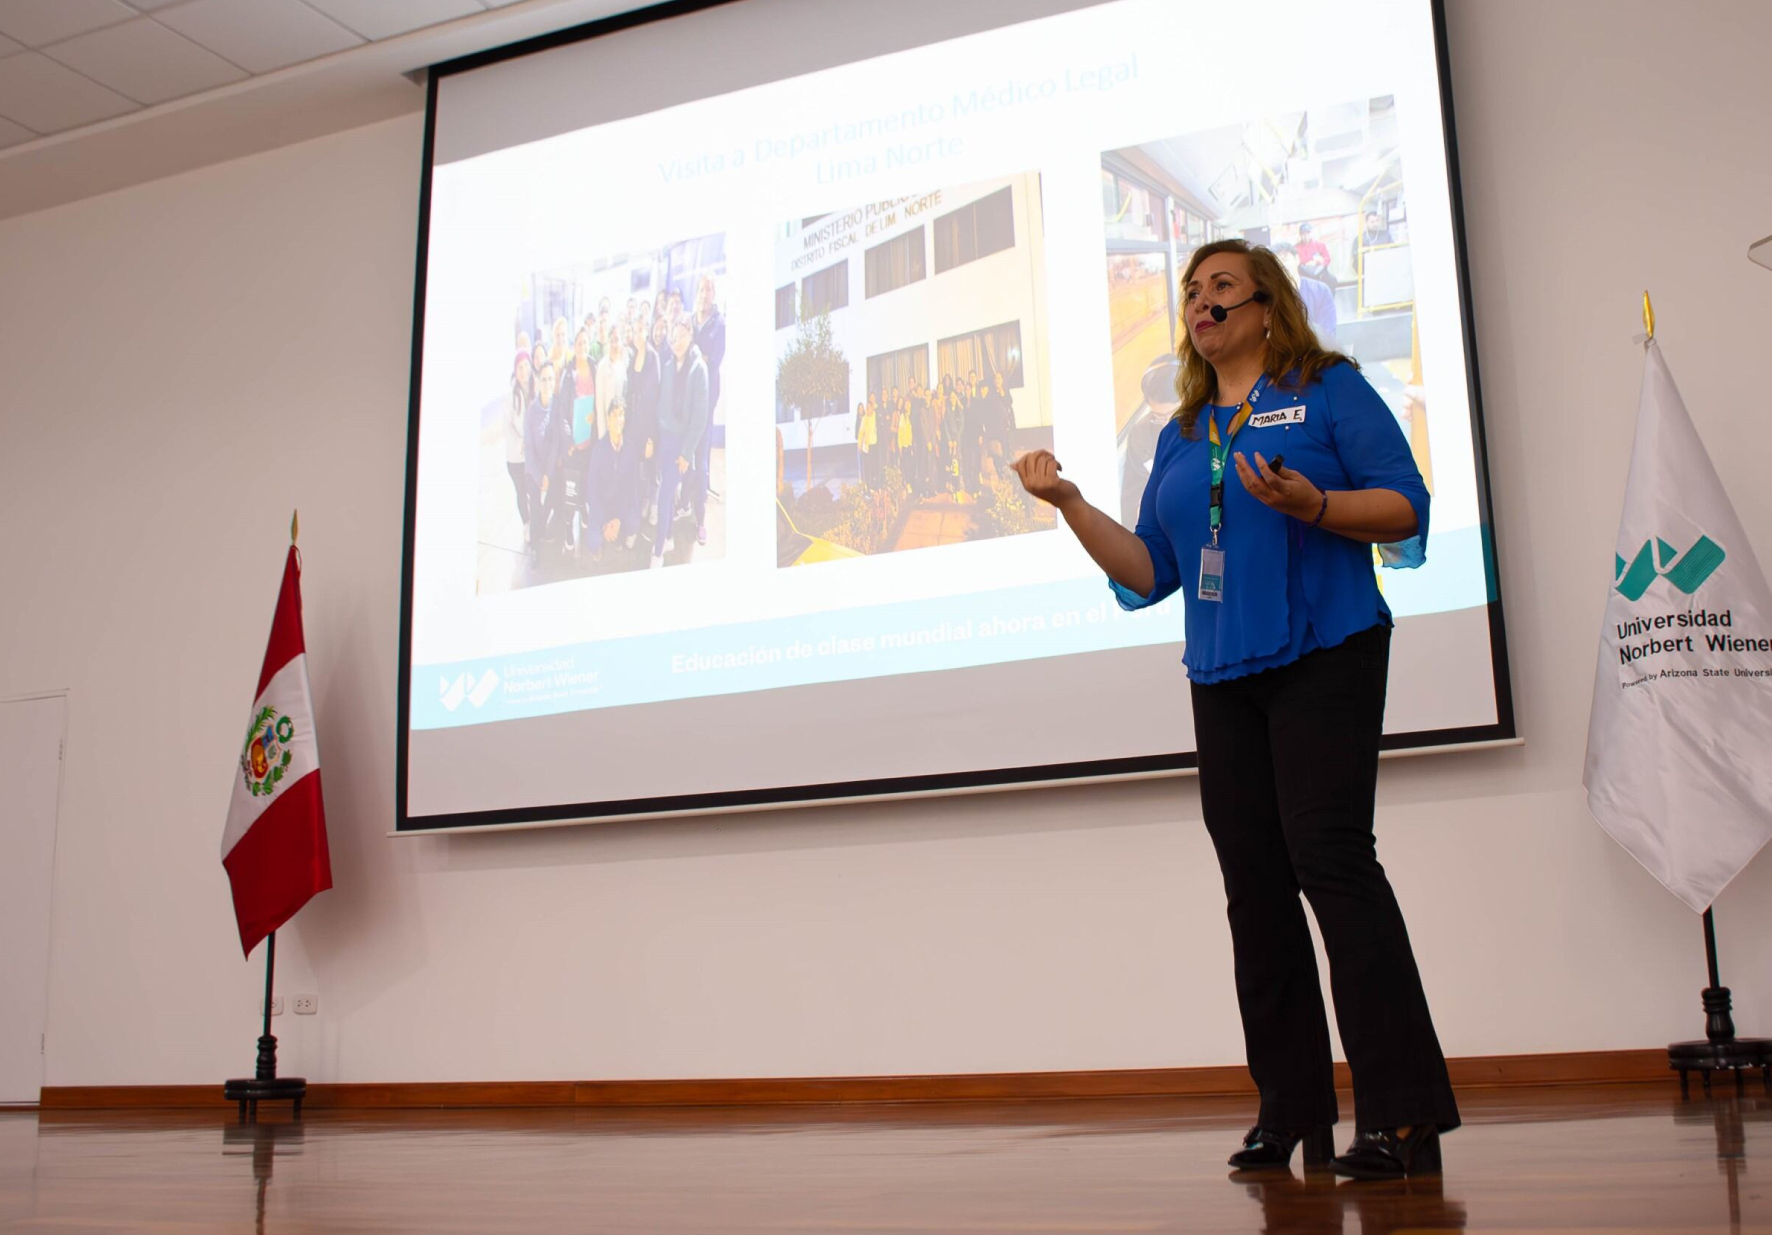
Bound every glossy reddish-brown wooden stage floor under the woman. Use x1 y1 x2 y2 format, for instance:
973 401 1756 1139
0 1081 1772 1235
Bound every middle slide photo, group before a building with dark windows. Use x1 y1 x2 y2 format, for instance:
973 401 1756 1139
774 174 1054 565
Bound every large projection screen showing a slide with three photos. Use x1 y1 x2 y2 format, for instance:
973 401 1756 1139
397 0 1513 831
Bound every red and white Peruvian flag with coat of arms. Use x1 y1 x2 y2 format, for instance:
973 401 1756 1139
222 544 331 955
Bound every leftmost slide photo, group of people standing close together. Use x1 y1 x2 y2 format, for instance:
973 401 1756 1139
477 234 727 595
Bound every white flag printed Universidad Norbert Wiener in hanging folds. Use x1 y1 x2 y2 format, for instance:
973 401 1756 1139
1581 342 1772 913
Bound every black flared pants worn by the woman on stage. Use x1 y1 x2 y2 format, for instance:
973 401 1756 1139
1193 625 1458 1130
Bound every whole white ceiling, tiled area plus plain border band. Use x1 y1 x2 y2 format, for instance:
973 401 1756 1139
0 0 652 220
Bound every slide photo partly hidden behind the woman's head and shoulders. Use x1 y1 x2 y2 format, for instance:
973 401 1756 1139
1100 94 1434 526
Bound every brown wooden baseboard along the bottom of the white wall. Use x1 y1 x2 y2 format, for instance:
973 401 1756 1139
43 1049 1673 1111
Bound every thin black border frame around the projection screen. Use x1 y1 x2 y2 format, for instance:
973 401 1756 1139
392 0 1520 836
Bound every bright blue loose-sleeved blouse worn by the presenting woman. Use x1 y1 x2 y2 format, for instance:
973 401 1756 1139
1109 365 1428 684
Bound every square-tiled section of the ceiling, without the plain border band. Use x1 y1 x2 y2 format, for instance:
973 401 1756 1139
0 0 514 139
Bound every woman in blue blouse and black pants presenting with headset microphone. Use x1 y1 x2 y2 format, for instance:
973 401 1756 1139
1015 241 1458 1178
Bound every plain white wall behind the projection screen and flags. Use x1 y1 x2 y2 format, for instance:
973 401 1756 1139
0 0 1772 1084
